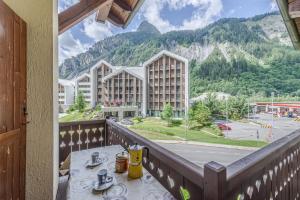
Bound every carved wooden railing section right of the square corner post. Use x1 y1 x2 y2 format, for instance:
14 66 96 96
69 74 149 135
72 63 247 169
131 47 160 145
223 131 300 200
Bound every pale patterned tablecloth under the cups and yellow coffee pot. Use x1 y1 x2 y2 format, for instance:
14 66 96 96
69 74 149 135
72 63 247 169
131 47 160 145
67 145 175 200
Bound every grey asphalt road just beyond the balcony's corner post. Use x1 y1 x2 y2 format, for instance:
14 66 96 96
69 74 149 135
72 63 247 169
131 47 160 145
159 143 254 167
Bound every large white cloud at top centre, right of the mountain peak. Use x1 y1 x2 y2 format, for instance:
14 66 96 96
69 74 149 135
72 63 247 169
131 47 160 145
142 0 223 33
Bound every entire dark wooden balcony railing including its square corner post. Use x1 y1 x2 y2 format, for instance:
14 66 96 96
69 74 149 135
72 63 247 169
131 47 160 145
59 120 300 200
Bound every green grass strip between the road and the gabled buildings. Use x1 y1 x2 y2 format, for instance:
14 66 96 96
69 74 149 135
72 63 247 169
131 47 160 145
129 118 267 147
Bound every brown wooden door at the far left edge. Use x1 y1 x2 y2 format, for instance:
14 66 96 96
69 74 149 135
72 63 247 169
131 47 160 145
0 0 26 200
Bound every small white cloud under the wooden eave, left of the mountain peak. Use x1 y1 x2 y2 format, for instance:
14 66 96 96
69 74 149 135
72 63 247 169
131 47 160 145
81 15 113 42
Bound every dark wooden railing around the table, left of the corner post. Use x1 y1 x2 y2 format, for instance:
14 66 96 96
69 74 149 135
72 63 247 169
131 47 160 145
59 120 203 199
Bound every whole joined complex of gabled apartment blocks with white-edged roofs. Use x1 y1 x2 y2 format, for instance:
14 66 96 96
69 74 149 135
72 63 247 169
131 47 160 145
59 51 189 118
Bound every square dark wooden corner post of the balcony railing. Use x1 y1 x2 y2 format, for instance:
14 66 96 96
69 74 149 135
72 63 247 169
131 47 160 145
204 162 226 200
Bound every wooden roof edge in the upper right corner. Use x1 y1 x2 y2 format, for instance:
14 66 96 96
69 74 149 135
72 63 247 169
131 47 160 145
277 0 300 49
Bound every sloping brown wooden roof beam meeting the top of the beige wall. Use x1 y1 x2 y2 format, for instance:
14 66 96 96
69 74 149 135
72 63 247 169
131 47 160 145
58 0 107 34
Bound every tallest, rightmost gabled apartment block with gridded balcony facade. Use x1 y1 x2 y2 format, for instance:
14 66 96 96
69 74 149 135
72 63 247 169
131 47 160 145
143 51 189 117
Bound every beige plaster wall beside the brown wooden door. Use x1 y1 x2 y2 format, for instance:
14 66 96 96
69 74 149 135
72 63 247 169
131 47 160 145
4 0 58 200
